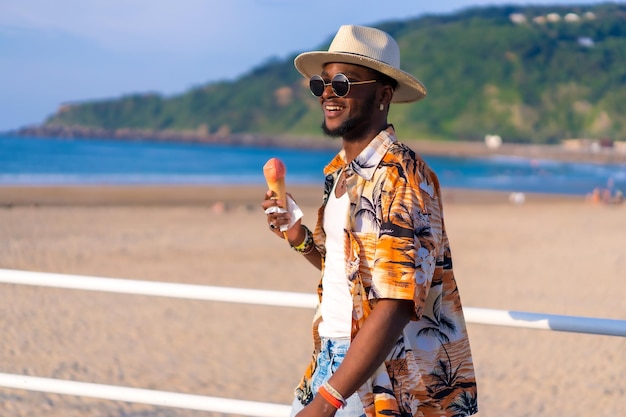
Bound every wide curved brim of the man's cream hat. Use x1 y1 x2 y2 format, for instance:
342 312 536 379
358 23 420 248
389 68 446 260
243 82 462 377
294 51 428 103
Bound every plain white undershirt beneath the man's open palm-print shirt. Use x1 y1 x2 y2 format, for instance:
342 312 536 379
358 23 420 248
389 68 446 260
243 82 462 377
319 181 352 338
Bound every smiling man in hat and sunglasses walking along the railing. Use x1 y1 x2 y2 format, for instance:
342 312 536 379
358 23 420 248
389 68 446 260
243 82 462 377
262 25 478 417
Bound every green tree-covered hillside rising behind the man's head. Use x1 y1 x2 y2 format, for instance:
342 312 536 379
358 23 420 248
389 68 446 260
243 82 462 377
45 4 626 143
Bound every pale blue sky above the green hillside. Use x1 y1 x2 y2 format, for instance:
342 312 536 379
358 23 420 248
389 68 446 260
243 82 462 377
0 0 601 132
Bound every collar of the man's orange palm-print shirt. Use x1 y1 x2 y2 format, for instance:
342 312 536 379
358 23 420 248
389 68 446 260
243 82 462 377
324 125 397 181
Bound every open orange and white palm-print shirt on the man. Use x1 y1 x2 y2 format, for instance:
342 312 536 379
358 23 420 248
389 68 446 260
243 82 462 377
296 126 478 417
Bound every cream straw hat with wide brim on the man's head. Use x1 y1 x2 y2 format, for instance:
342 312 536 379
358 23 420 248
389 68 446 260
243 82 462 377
294 25 427 103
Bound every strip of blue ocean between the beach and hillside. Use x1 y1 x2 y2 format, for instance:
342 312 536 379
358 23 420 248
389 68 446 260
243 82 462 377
0 135 626 195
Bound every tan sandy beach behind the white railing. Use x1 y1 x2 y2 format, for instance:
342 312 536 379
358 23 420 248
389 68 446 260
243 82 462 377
0 186 626 417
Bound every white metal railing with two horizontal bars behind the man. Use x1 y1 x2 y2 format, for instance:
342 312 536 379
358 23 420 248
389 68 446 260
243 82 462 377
0 269 626 417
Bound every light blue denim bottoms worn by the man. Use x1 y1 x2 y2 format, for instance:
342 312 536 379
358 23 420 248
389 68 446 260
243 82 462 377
290 337 365 417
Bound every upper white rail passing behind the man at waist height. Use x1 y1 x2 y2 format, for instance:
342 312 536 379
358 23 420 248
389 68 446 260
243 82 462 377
0 269 626 337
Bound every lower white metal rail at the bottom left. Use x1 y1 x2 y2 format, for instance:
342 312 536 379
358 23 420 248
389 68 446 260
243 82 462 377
0 373 291 417
